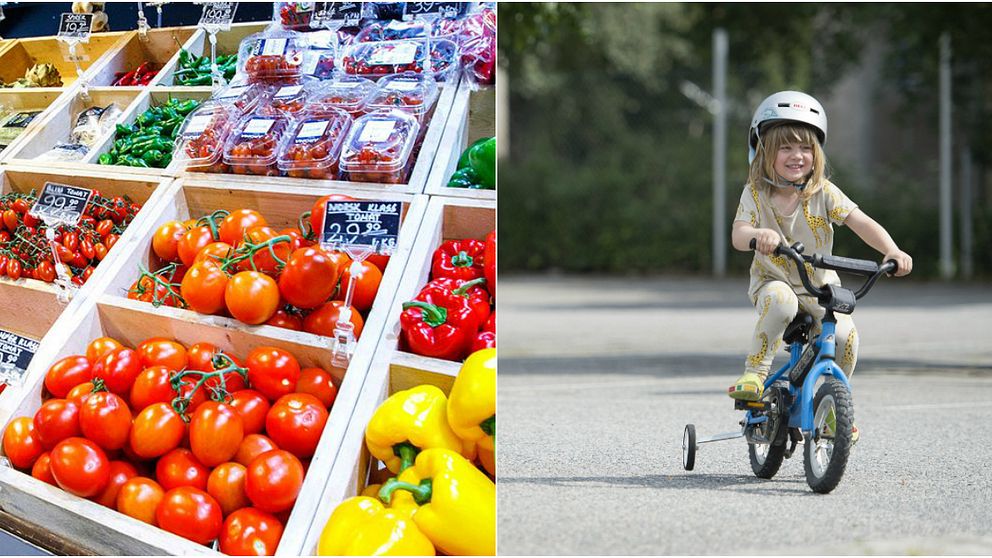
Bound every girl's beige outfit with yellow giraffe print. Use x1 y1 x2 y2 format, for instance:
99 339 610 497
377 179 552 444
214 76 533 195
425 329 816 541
734 181 858 378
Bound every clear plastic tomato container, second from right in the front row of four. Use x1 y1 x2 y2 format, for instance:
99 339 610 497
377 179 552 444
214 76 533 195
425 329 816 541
278 107 351 180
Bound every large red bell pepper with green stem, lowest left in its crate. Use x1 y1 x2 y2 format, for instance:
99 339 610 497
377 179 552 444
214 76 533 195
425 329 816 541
400 289 479 360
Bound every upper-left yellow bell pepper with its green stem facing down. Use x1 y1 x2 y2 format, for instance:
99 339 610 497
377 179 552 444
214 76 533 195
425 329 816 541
365 385 475 473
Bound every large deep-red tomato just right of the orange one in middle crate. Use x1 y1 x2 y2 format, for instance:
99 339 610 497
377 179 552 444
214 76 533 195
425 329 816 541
279 247 341 308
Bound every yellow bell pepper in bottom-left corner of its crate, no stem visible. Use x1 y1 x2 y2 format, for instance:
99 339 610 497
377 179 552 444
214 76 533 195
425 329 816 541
317 496 436 556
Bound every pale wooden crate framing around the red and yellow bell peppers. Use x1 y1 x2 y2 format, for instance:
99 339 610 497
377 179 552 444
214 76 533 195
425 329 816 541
302 197 496 554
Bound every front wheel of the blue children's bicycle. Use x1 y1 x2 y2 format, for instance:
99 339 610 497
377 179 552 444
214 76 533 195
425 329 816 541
804 377 854 494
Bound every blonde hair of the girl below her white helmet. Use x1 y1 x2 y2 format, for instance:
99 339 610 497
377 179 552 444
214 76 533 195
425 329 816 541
747 123 827 200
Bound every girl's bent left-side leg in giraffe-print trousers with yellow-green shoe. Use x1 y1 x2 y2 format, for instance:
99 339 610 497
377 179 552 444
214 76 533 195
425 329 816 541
728 281 799 400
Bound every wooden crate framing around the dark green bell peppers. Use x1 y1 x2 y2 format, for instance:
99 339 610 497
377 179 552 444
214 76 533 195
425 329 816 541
424 79 496 200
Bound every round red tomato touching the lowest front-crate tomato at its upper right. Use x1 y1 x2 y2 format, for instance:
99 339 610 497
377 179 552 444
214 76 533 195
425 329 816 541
245 450 304 513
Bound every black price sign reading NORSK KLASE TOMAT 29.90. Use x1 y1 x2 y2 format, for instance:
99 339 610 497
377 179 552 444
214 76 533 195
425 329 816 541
320 201 402 254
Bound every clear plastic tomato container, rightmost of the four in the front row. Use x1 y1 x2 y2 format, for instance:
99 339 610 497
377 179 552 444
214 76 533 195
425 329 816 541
340 110 420 184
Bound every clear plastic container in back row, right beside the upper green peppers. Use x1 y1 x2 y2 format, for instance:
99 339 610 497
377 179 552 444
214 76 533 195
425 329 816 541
238 28 305 83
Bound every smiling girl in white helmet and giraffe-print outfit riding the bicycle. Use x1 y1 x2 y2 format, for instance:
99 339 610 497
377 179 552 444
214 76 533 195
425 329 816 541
728 91 913 440
